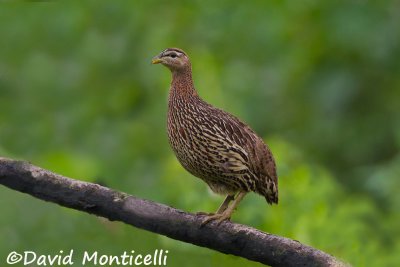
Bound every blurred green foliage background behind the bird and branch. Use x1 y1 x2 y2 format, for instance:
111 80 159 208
0 0 400 266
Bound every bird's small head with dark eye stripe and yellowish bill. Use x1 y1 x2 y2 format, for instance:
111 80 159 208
151 48 190 72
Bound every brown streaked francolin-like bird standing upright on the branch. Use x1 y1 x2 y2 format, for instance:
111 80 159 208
151 48 278 225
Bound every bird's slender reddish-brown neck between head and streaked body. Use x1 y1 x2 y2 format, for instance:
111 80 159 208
169 67 197 98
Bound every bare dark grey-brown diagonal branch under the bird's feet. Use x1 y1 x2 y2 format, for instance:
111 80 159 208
0 158 345 266
